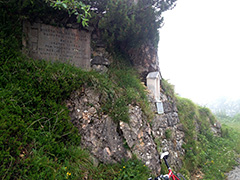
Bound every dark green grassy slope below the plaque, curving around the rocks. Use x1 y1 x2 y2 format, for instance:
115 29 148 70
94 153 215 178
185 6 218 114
0 52 153 179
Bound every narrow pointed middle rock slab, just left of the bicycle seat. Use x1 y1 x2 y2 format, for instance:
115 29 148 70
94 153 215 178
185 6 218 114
120 105 161 173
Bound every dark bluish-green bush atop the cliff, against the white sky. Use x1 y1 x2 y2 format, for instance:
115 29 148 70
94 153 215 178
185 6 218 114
84 0 176 53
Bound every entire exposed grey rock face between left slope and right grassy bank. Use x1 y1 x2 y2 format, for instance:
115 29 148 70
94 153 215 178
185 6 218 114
66 88 184 174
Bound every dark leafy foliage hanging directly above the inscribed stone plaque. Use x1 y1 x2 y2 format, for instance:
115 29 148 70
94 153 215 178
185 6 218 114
0 0 90 26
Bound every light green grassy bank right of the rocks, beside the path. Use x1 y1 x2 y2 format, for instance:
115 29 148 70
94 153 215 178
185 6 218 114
177 97 240 180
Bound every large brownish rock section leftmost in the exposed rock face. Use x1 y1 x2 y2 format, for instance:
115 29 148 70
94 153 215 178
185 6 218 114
67 89 131 163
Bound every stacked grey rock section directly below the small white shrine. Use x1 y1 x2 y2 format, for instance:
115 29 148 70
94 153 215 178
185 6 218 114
152 92 185 169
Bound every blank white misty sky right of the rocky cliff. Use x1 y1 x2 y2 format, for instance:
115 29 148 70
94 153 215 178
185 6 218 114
158 0 240 105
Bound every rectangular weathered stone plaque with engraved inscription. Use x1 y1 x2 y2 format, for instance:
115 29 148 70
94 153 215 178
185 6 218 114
23 22 91 70
